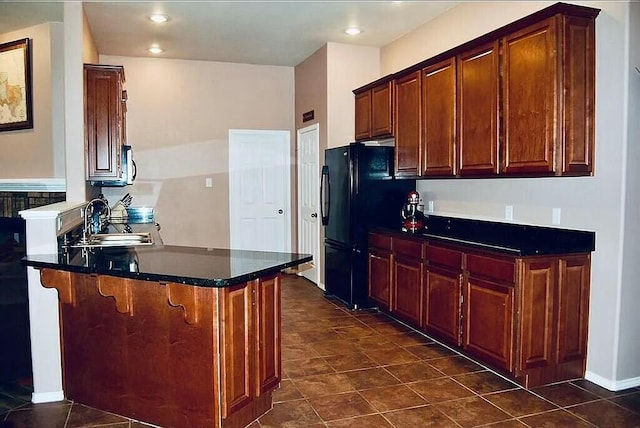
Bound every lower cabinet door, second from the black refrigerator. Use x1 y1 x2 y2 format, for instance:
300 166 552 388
391 255 422 327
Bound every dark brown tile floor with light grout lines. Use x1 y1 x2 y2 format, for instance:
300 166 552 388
0 276 640 428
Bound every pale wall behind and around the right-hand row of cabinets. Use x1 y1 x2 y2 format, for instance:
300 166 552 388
381 1 640 389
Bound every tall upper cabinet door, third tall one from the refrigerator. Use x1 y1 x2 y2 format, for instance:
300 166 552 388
458 41 499 176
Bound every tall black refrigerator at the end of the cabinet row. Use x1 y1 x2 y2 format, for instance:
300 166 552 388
320 143 416 309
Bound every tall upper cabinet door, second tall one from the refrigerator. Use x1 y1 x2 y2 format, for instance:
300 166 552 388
422 57 456 176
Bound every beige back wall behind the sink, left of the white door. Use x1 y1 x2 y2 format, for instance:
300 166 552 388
100 55 294 248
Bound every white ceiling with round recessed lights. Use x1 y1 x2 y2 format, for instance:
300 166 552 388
0 0 459 66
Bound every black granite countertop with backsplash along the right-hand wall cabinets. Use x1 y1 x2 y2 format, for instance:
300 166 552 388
378 215 596 257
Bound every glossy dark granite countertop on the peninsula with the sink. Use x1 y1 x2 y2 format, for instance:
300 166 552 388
22 245 312 287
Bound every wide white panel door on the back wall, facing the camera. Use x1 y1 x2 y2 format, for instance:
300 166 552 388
229 129 291 252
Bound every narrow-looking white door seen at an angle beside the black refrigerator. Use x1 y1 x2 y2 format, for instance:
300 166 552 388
297 124 322 288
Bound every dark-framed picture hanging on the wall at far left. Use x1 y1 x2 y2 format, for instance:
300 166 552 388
0 39 33 131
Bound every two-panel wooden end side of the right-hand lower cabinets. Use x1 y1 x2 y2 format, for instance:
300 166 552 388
515 255 590 386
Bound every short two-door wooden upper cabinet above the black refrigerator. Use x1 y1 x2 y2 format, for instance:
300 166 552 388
354 79 393 141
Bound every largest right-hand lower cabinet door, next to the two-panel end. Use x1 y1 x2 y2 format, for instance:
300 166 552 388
463 277 514 372
